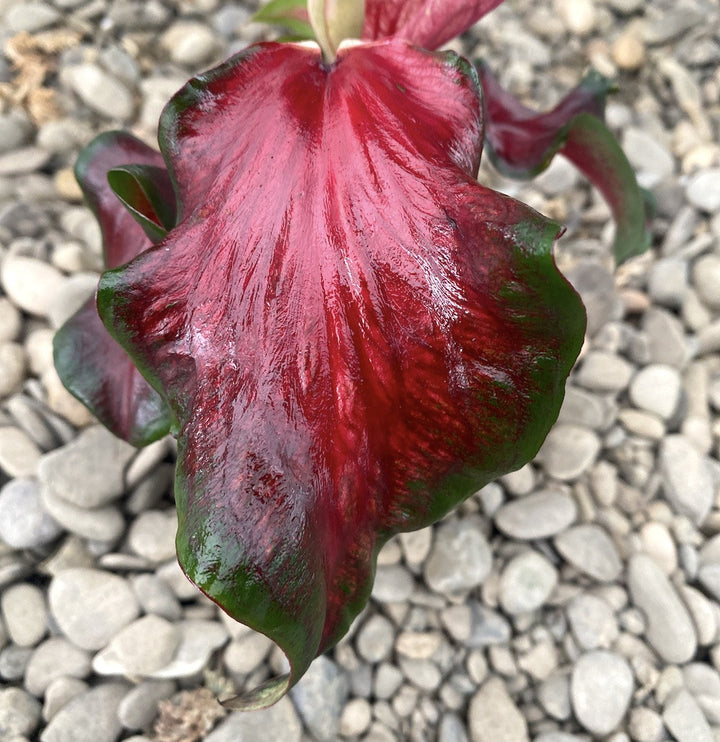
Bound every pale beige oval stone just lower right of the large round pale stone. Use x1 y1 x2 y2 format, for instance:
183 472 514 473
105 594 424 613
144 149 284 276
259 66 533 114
93 615 180 677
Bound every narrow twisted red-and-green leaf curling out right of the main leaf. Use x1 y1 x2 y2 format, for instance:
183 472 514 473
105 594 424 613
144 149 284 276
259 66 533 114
478 62 649 263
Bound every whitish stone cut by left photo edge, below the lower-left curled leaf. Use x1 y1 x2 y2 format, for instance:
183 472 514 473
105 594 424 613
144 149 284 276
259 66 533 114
0 479 62 549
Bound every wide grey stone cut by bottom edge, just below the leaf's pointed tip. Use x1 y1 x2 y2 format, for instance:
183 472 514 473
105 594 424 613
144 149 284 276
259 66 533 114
205 697 303 742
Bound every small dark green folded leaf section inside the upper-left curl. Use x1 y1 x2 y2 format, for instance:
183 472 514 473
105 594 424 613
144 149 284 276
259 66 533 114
107 164 175 242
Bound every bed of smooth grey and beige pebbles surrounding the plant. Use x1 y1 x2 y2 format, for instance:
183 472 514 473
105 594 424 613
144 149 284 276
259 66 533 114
0 0 720 742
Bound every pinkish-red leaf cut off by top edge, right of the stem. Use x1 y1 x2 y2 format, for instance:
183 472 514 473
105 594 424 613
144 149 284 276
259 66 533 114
363 0 503 49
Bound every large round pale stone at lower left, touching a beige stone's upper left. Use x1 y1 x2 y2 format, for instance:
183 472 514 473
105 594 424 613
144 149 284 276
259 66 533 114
48 568 140 649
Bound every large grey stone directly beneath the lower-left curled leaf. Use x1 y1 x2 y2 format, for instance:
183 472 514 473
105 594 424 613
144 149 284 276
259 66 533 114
38 425 135 508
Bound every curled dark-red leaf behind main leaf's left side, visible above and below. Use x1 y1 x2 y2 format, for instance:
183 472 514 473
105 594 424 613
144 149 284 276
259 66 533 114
53 132 174 446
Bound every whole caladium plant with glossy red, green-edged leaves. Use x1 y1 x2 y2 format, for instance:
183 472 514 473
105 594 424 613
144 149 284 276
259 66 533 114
55 0 646 708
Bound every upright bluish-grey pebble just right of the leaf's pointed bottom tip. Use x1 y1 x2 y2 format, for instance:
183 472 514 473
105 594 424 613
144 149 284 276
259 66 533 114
290 656 349 742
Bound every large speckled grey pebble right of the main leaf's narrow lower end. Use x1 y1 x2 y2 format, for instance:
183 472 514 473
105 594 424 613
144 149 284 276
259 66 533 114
424 519 492 593
